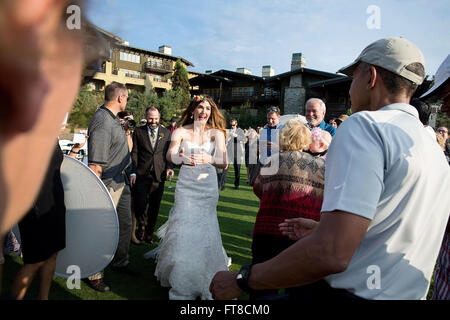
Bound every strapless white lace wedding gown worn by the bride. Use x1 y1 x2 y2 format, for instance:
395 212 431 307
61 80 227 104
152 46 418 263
155 141 232 300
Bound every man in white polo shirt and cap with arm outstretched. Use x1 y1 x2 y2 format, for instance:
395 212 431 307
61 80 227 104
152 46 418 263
210 38 450 299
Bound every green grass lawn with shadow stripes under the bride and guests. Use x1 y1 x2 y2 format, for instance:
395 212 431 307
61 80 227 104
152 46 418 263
0 166 259 300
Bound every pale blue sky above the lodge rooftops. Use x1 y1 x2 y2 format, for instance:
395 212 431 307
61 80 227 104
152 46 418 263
87 0 450 76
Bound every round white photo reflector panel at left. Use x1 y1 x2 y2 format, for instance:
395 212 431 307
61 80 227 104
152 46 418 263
55 156 119 278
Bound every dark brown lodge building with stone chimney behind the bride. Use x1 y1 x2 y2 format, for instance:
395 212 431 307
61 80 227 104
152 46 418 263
189 53 351 121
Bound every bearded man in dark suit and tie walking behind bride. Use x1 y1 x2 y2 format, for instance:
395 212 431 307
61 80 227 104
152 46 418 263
131 107 174 243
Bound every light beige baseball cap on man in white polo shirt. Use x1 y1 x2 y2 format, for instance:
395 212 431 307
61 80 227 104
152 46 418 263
338 37 425 85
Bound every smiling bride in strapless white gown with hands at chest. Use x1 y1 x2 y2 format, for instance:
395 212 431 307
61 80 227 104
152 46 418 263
155 96 232 300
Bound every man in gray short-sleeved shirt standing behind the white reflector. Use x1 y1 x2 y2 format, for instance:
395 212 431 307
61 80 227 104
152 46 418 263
88 82 138 292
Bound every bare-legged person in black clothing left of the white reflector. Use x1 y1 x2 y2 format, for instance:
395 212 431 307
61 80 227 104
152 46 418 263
11 145 66 300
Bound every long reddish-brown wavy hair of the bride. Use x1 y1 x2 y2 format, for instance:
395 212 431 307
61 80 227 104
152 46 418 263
178 95 226 136
